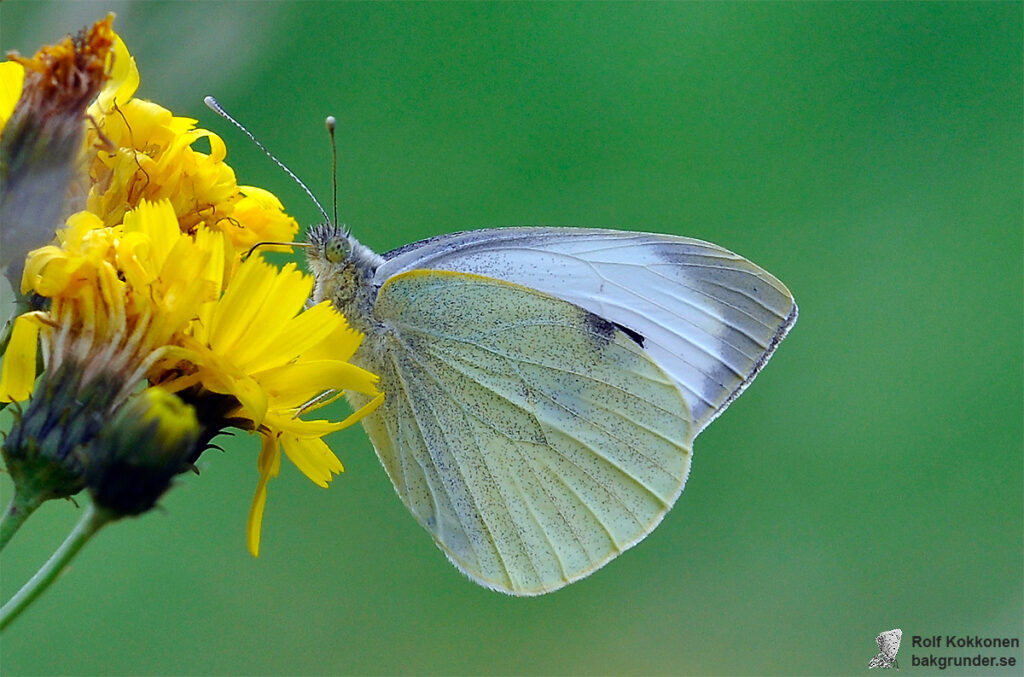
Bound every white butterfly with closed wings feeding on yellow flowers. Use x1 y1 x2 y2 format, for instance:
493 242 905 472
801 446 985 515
308 224 797 595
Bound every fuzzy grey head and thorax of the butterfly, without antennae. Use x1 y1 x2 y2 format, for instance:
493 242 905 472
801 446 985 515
306 223 384 334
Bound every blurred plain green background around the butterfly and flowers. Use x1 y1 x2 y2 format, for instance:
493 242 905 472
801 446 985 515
0 0 1024 675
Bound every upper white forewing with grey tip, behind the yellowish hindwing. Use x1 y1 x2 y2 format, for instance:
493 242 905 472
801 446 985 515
376 227 797 434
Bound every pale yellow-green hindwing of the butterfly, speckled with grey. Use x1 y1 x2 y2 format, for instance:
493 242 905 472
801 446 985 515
348 270 693 595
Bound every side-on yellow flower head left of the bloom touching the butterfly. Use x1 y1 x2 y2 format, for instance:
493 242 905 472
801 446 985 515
8 202 223 403
